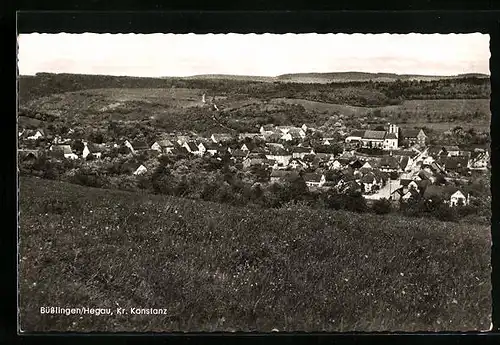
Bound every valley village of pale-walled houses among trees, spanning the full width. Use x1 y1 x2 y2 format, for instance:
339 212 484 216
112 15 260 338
19 110 490 211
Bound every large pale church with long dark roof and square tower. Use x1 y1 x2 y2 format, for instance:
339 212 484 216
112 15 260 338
345 124 399 150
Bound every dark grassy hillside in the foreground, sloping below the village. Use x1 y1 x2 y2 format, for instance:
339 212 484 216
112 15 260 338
19 177 491 331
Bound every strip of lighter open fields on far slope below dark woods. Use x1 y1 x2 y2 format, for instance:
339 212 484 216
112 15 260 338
22 88 491 125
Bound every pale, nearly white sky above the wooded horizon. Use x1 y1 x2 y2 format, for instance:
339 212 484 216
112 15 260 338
18 33 490 77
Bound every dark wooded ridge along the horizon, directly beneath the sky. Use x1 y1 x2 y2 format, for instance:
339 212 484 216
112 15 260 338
19 73 490 106
